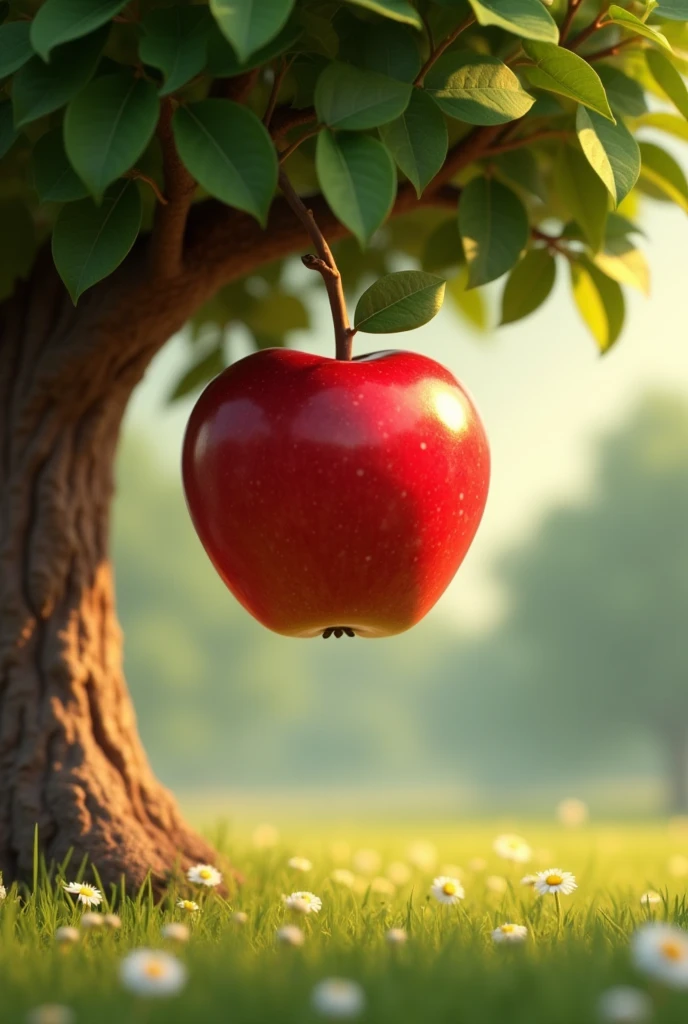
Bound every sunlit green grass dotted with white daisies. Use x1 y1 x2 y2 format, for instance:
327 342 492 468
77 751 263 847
0 823 688 1024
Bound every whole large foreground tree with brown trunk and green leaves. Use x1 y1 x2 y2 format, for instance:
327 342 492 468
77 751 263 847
0 0 688 884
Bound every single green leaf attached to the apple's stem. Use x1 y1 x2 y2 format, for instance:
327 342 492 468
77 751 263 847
353 270 444 334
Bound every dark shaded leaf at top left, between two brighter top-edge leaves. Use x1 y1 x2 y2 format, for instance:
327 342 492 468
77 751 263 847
138 5 209 96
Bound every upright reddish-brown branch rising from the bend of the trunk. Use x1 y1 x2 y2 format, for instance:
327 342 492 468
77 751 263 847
151 99 196 278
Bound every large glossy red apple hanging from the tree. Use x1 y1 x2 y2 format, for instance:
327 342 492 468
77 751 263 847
182 348 489 637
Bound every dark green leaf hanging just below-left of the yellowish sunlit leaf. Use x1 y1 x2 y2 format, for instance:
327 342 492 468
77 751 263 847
380 89 447 197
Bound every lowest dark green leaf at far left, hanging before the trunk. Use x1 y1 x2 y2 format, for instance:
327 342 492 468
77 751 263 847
52 181 141 305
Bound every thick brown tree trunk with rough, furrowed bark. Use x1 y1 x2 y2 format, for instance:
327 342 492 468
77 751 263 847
0 256 220 887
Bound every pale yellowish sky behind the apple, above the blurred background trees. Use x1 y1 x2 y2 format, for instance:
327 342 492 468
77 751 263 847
125 191 688 629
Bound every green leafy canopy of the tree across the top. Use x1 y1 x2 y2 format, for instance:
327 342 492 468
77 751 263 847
0 0 688 394
